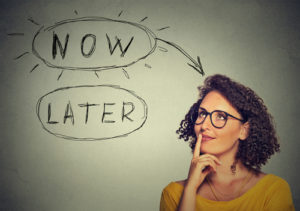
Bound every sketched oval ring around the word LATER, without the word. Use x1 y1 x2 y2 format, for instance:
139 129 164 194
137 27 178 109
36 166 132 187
36 85 148 141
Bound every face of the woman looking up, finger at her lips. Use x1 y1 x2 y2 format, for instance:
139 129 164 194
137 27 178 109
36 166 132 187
194 91 247 155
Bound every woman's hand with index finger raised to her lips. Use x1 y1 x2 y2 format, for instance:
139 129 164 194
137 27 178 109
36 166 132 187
186 134 221 191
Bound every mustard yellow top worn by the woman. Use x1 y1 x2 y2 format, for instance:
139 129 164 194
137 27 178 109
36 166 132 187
160 174 295 211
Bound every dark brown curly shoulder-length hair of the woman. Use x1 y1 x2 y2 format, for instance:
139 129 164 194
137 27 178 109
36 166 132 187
176 74 280 172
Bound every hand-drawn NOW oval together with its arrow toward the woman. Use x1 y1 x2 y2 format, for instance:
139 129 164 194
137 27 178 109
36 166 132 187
30 16 204 75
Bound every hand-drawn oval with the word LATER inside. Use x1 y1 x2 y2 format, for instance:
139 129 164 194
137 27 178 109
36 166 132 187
36 85 148 141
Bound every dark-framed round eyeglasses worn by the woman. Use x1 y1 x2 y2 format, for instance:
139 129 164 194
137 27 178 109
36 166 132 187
195 108 245 128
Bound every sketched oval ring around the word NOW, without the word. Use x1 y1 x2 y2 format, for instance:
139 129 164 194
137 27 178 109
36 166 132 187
32 17 157 71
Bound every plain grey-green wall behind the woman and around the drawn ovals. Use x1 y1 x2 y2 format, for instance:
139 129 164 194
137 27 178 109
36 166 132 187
0 0 300 210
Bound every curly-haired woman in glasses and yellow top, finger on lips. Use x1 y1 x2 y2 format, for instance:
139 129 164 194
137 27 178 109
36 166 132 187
160 75 295 211
